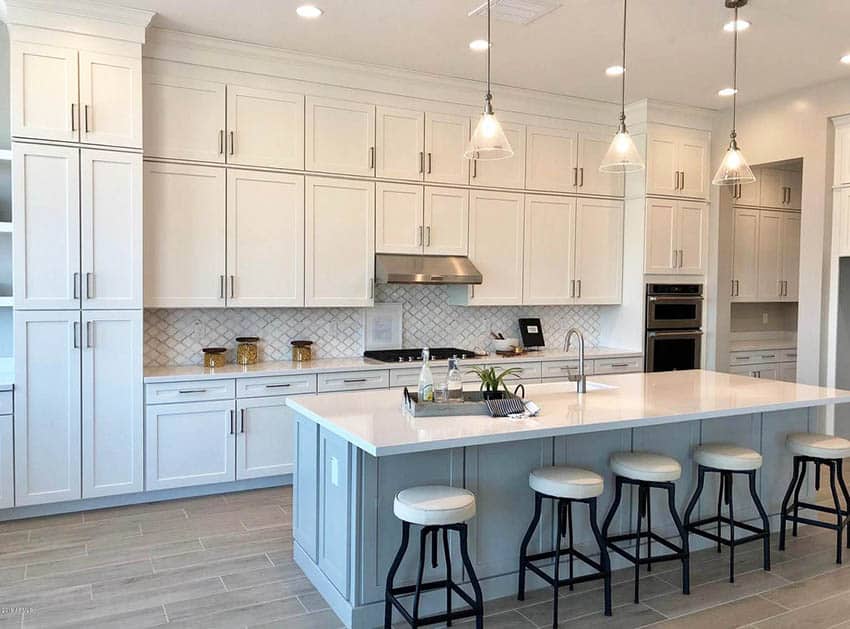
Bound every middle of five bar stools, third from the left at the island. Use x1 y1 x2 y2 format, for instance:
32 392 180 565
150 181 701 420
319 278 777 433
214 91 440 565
602 452 691 604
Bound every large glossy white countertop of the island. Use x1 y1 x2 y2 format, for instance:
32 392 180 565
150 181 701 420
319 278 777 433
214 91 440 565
287 370 850 456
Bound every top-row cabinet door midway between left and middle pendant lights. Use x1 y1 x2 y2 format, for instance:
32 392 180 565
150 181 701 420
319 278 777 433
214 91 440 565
525 127 578 192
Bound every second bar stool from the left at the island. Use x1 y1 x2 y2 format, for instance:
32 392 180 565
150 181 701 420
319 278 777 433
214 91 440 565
517 466 611 627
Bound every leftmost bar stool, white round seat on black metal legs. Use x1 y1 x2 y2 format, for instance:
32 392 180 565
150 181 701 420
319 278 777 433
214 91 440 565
384 485 484 629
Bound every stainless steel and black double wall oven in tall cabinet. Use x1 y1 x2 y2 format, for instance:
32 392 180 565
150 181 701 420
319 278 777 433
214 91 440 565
644 284 703 372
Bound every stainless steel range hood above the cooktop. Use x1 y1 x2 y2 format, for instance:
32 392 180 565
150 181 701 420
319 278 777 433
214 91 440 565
375 253 482 284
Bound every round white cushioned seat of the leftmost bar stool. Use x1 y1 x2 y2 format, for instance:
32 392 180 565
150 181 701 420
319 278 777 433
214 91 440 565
393 485 475 526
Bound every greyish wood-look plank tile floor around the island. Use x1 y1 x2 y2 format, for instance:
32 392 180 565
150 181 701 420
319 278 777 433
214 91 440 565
0 487 850 629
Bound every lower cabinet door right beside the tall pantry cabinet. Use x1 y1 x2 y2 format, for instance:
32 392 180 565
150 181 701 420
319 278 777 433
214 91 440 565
145 400 236 490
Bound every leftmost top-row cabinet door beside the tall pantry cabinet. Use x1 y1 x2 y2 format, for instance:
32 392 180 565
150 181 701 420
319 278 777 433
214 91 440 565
144 75 225 163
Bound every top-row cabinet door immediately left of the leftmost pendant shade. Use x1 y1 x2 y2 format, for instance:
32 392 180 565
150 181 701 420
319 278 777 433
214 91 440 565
425 113 469 185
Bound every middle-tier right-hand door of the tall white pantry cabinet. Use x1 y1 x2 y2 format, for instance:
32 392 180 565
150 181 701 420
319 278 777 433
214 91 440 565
80 149 143 309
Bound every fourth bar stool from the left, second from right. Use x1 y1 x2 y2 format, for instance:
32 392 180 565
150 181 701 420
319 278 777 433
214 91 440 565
685 443 770 583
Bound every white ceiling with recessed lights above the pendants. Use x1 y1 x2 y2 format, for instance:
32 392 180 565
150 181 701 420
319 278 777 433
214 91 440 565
104 0 850 108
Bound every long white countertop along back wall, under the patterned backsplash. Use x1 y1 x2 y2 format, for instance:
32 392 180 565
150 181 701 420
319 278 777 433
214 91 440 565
145 347 641 383
